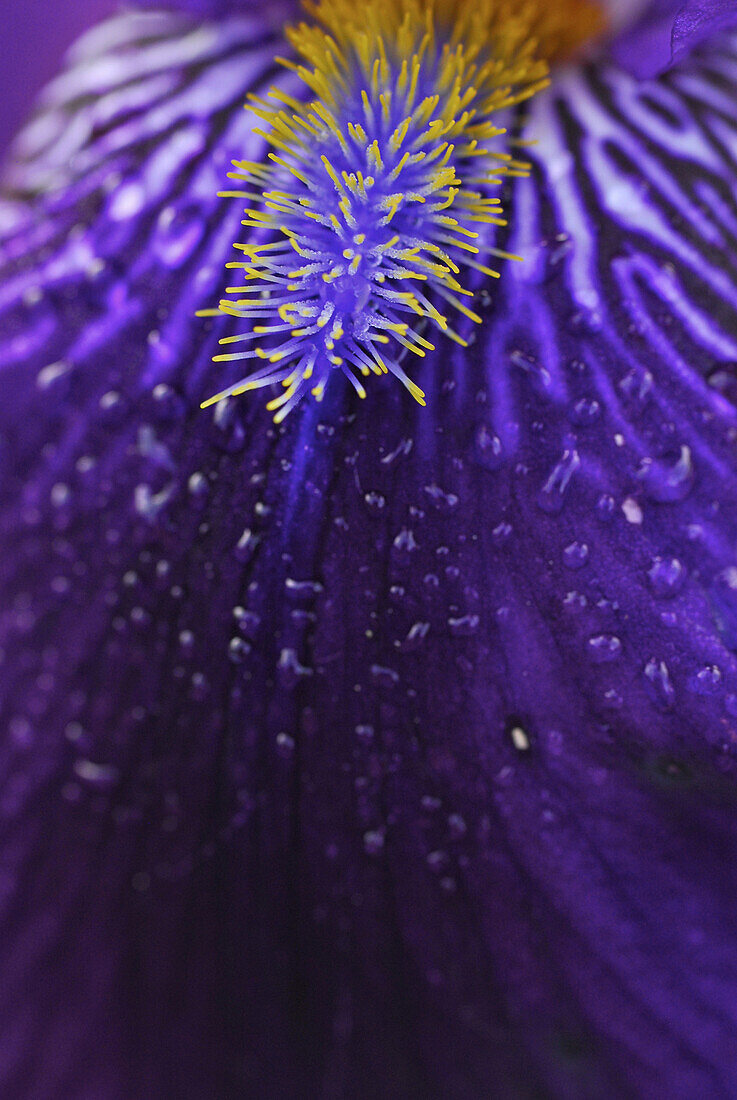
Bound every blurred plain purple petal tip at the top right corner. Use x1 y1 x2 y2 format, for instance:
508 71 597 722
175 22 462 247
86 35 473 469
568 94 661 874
612 0 737 79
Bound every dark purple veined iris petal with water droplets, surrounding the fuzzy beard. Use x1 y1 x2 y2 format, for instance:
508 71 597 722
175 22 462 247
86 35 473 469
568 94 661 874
0 0 737 1100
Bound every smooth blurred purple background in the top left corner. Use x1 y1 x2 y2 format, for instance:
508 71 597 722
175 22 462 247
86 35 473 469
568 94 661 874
0 0 120 156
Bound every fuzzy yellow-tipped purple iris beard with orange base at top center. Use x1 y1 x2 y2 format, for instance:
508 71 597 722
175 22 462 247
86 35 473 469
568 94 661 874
205 0 601 422
